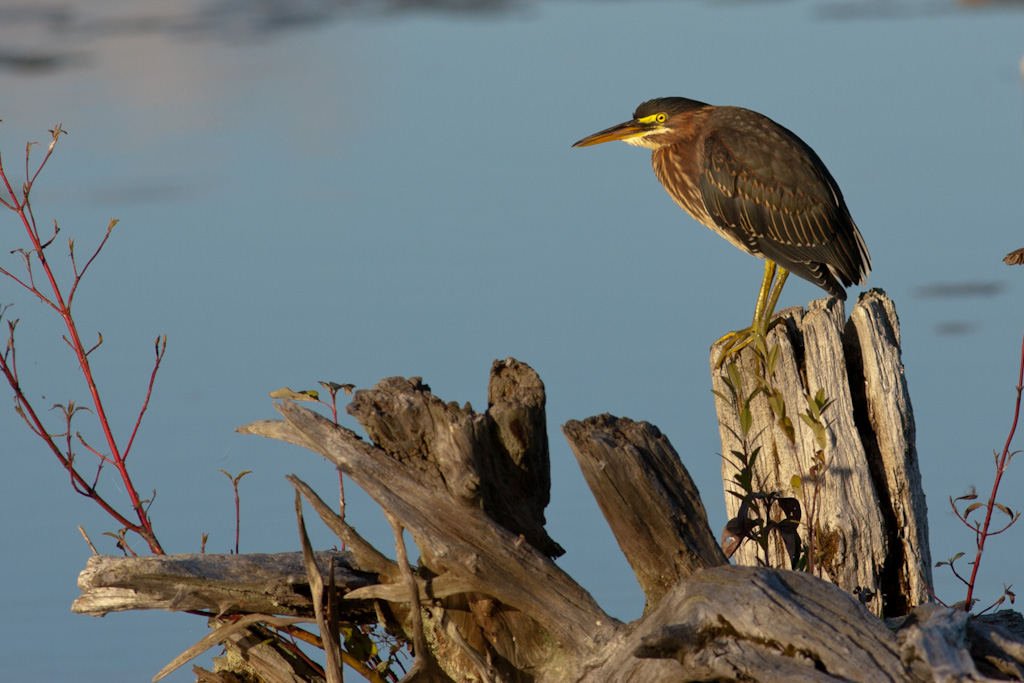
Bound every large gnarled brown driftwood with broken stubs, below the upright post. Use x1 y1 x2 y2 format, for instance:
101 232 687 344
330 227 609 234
76 308 1024 683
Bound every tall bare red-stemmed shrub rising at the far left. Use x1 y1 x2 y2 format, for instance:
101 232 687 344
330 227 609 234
0 132 164 555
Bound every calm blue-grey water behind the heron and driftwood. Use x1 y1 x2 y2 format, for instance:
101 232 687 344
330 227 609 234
0 0 1024 681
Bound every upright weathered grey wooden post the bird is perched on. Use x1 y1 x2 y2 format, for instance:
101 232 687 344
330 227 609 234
711 290 931 616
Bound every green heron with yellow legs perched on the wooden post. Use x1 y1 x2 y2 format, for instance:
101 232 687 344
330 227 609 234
572 97 871 364
